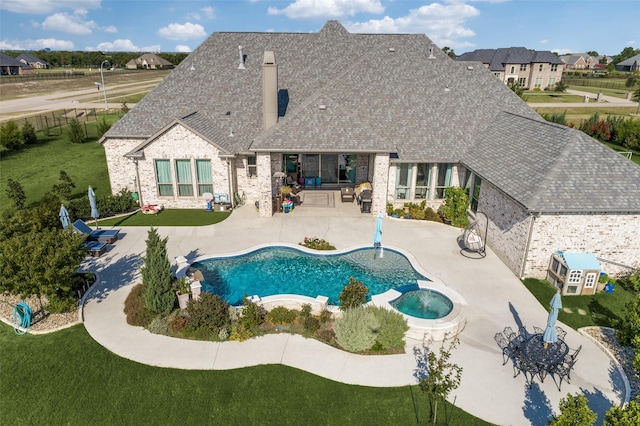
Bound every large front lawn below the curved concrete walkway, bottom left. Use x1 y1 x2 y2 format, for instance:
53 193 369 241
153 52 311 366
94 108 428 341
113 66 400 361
0 324 488 425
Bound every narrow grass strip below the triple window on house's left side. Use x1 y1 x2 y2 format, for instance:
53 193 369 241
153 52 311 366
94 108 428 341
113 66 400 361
99 209 231 227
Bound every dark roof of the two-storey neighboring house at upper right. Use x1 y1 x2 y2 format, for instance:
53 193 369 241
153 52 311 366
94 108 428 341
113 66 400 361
456 47 562 71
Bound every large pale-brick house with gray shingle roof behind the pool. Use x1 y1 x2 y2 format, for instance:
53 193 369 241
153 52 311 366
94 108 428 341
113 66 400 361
101 21 640 278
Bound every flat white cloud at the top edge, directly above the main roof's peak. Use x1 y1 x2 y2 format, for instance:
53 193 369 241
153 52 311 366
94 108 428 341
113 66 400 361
267 0 384 19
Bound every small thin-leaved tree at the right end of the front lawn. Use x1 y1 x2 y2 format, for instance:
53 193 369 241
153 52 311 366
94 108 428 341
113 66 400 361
419 336 462 424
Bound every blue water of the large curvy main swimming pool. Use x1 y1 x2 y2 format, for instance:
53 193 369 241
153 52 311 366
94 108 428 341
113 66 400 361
191 246 428 305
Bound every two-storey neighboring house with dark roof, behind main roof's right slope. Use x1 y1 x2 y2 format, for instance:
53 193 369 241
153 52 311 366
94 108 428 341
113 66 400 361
456 47 564 90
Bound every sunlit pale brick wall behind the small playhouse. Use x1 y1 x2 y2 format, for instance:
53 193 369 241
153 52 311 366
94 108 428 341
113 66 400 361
525 213 640 278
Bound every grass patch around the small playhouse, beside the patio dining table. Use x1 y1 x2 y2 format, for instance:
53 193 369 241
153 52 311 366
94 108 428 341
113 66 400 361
523 278 636 329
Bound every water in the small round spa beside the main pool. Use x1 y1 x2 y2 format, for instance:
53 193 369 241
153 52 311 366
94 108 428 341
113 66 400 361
390 288 453 319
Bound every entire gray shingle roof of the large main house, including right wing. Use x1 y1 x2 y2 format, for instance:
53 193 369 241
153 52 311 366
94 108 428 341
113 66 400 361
105 21 640 211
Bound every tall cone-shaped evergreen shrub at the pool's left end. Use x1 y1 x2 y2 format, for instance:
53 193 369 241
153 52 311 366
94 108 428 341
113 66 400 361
140 227 176 314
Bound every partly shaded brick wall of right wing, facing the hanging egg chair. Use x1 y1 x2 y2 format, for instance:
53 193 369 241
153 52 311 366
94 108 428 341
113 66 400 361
477 180 531 276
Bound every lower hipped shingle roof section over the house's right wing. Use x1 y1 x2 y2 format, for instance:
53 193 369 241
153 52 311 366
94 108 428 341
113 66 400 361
462 113 640 211
